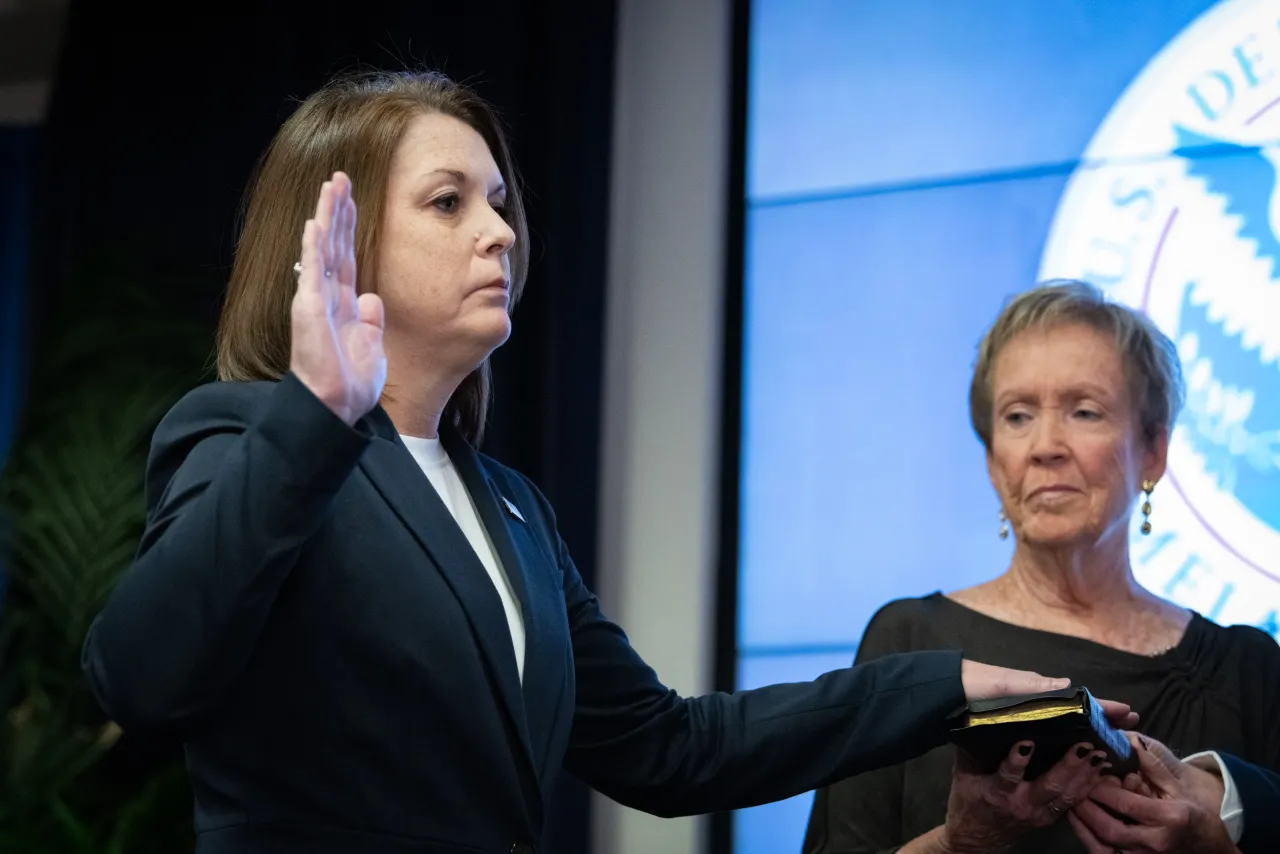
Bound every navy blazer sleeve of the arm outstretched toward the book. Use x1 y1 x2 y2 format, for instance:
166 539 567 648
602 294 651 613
559 542 964 817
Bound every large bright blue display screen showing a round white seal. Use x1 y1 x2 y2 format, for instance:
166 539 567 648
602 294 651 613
733 0 1280 854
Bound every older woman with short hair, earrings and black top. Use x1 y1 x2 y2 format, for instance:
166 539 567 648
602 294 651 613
804 282 1280 854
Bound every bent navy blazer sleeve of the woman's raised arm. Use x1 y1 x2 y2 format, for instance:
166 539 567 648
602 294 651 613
82 375 369 730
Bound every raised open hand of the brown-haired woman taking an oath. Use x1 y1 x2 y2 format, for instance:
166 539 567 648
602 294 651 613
289 172 387 425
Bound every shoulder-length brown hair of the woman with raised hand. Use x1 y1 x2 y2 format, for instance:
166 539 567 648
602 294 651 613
218 72 529 444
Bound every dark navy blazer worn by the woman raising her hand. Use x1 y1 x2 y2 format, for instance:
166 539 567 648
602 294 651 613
83 375 964 854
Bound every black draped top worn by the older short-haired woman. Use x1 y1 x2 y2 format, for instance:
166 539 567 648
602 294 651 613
804 593 1280 854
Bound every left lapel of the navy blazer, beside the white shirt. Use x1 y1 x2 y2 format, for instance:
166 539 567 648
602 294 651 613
360 407 536 777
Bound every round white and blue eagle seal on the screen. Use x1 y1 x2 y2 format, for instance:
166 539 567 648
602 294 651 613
1039 0 1280 636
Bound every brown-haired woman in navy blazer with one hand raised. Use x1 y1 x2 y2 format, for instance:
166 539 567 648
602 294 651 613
83 74 1100 854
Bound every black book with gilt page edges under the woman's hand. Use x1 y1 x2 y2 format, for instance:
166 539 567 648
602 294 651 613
950 688 1138 780
